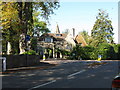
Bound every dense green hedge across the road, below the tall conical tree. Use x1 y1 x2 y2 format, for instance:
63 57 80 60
70 43 118 60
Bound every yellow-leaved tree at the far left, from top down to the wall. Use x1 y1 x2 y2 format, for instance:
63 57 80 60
0 2 19 54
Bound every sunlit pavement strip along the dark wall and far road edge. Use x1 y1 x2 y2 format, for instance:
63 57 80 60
0 59 118 74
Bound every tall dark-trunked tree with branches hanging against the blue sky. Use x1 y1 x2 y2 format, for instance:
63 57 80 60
18 2 59 52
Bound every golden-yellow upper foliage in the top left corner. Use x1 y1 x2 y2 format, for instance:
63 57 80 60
0 2 19 30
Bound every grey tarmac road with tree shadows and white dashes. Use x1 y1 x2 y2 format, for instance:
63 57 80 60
2 61 119 90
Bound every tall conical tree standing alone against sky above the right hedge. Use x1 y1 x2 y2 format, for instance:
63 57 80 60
91 9 114 46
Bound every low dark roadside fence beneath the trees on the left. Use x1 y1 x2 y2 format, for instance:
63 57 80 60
2 55 40 69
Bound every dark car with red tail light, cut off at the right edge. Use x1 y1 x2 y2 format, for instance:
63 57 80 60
112 73 120 90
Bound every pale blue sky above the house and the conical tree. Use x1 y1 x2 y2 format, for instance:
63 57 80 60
48 0 118 43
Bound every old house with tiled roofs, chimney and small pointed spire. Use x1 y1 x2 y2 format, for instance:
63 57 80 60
37 25 87 58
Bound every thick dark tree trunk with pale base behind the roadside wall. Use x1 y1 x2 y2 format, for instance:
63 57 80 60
18 2 33 54
